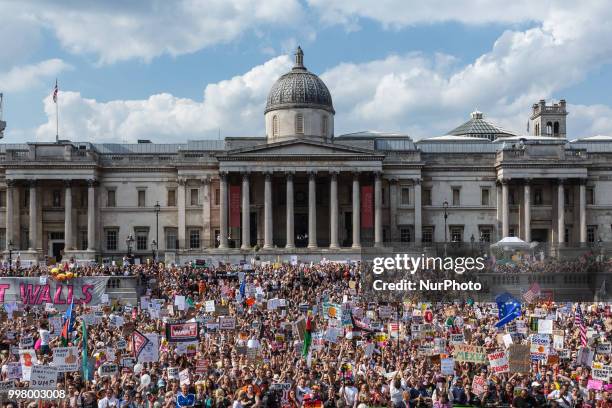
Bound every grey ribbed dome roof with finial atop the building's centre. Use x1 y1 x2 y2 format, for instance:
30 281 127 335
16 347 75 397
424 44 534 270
264 47 335 114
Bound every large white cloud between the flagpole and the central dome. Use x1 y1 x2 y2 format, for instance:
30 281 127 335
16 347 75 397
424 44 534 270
36 56 291 143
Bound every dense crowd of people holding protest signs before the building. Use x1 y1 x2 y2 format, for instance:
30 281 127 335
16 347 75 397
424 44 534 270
0 255 612 408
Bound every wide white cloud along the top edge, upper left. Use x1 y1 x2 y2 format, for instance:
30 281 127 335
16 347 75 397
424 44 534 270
10 0 302 63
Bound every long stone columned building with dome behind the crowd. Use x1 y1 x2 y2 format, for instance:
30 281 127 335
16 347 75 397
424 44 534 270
0 48 612 262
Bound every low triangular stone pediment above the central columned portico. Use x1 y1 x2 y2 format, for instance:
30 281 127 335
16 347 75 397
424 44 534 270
221 140 377 157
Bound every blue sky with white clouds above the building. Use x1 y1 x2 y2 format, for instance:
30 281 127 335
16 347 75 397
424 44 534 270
0 0 612 143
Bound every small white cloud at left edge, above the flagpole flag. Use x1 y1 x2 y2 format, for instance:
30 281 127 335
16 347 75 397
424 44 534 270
0 58 72 92
